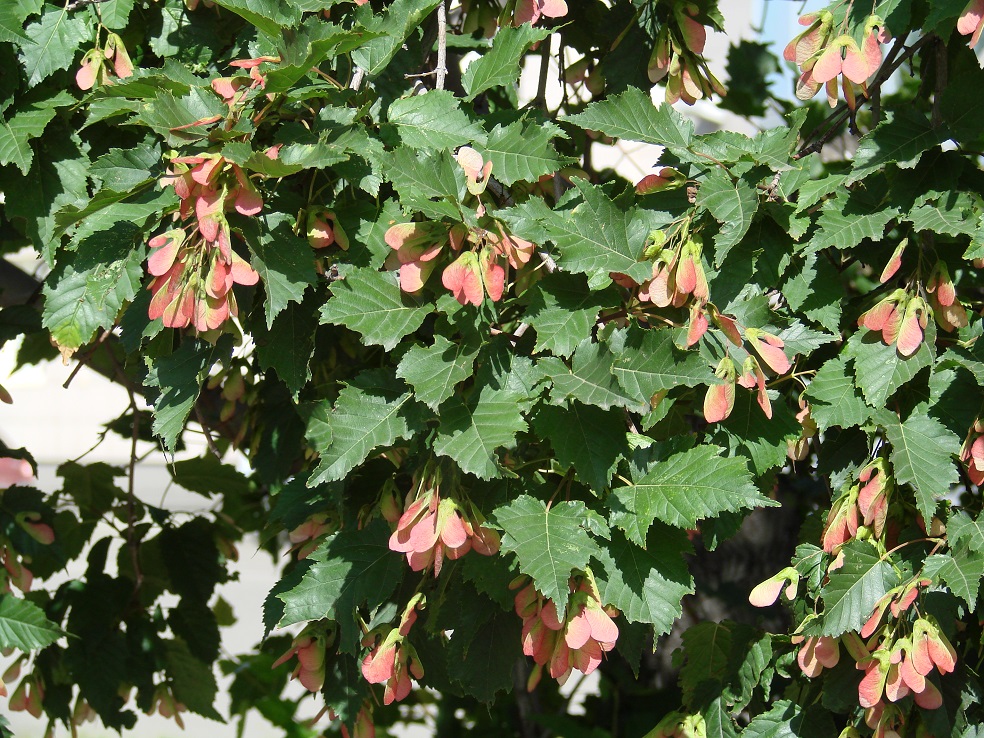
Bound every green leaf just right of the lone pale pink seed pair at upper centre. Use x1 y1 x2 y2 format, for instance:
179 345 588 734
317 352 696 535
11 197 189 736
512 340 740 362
475 118 573 186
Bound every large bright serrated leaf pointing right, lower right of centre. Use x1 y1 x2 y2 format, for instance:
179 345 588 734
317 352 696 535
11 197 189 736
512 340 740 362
611 445 779 546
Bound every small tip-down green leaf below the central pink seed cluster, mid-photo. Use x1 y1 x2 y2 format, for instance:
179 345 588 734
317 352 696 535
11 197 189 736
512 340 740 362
396 335 479 411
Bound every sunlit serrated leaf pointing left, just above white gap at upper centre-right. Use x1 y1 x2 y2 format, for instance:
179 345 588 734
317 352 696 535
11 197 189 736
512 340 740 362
561 87 694 150
